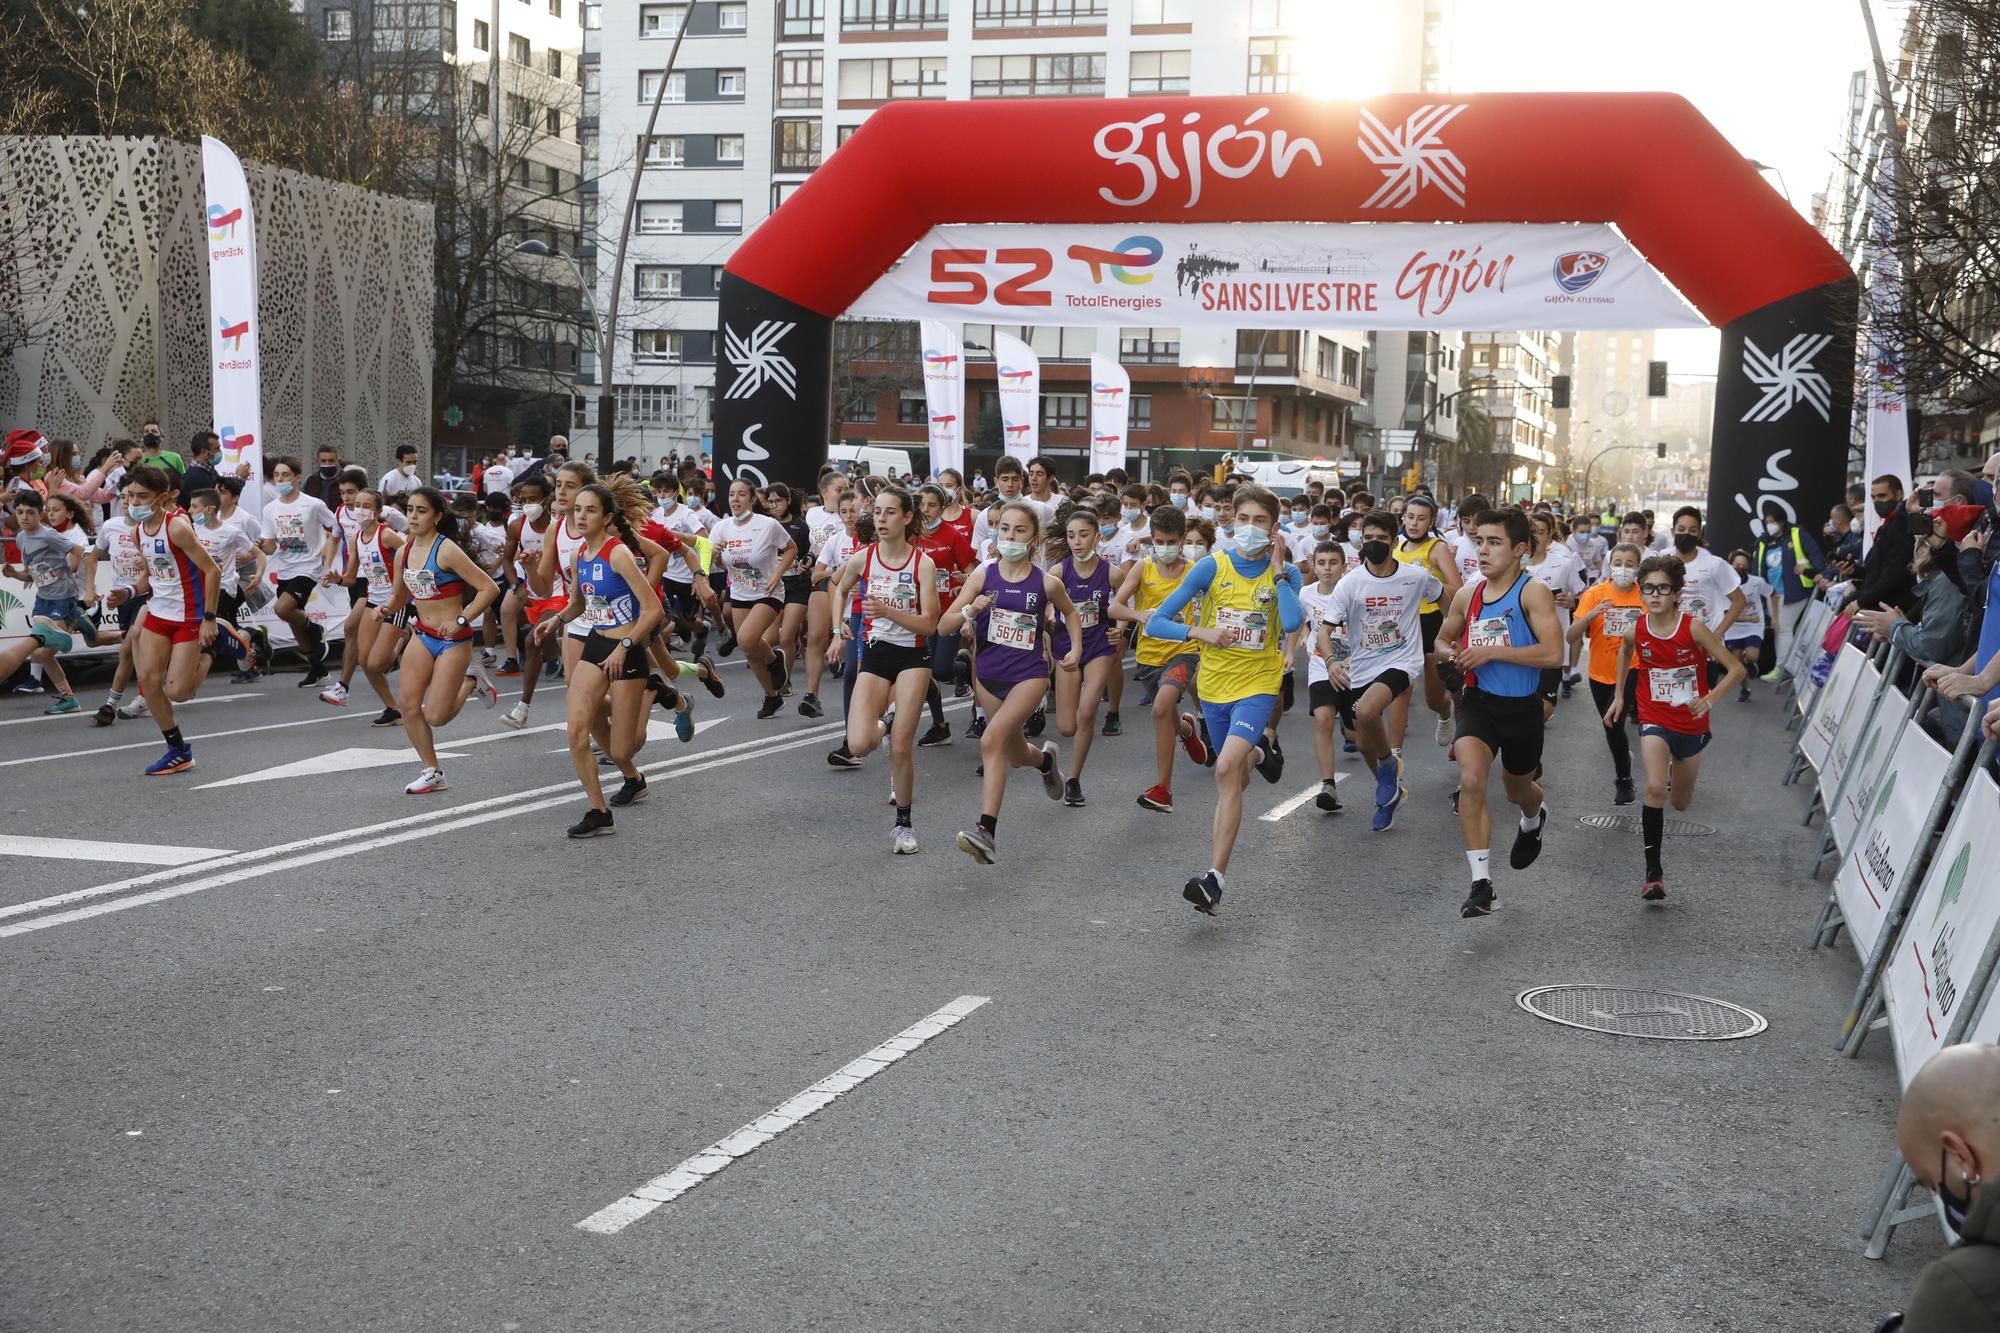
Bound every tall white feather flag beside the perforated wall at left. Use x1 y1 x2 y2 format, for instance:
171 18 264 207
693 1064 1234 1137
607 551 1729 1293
202 134 264 510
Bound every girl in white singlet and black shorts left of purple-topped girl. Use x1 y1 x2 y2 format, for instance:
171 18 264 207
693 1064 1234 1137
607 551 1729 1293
820 486 938 857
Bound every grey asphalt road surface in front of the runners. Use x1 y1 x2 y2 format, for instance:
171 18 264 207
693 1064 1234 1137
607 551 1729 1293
0 667 1940 1331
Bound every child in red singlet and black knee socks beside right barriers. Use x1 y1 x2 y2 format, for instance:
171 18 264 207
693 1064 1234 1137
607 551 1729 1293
1604 544 1744 903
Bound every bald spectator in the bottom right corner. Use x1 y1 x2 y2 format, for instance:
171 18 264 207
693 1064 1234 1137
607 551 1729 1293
1890 1043 2000 1333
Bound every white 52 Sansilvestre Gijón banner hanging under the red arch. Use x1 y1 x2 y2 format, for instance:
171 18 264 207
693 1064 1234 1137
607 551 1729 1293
848 222 1708 328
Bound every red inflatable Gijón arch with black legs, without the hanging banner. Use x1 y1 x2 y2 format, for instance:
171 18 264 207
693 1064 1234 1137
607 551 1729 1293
716 92 1856 544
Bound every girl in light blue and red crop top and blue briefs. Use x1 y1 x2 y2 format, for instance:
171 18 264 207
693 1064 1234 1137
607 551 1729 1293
374 486 500 797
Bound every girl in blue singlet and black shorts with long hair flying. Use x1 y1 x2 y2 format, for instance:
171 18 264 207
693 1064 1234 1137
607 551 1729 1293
534 482 682 839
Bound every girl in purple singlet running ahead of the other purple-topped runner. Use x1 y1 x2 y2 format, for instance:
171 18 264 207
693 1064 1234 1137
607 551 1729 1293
938 500 1084 865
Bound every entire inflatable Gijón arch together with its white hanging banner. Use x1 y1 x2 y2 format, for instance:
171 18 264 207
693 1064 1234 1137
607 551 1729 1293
714 92 1858 548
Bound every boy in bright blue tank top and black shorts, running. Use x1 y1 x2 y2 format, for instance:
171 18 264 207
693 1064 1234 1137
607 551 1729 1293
1438 508 1562 917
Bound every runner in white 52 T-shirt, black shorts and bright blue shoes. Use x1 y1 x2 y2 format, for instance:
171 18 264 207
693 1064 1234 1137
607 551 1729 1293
1320 508 1444 833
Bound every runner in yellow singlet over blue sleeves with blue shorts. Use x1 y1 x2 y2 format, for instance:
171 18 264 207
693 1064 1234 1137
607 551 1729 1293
1146 486 1296 917
